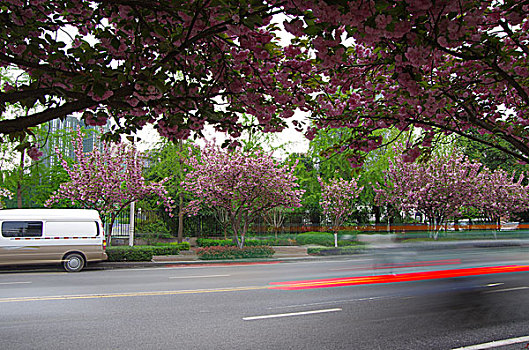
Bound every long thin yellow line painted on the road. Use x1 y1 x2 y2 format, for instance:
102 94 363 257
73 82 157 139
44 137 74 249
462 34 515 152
0 286 269 303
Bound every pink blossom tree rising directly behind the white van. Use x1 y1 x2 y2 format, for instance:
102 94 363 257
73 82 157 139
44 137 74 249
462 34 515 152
45 132 174 242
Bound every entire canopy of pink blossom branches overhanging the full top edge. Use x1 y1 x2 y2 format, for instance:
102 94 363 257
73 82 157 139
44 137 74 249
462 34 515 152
0 0 529 163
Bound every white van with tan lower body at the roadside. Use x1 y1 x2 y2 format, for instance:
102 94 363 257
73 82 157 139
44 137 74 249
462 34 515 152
0 209 107 272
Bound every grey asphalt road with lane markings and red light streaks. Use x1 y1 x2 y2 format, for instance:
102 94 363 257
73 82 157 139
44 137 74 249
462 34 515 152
0 246 529 350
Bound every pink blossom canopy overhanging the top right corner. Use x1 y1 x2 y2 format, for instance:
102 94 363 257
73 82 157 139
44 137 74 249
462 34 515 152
292 0 529 163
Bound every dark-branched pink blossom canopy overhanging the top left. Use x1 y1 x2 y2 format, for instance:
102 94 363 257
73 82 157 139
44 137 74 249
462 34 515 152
0 0 313 145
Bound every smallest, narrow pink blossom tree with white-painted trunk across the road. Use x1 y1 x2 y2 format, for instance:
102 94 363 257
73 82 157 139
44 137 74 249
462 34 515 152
319 178 363 247
